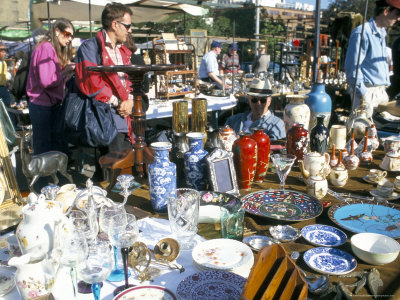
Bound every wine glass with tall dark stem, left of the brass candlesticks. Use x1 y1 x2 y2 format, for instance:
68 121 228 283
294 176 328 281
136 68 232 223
108 214 139 296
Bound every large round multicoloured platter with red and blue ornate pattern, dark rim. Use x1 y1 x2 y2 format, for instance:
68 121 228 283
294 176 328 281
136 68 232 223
242 190 323 222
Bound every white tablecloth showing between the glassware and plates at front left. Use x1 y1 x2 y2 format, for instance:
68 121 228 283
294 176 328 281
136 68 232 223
0 218 250 300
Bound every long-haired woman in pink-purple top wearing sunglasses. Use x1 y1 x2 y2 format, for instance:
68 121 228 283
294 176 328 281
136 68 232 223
26 18 75 154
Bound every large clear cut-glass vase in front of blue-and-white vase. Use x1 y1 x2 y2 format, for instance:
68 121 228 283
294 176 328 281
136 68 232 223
168 188 200 250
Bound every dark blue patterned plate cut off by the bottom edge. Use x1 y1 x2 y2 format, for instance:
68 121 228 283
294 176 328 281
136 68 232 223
176 271 246 300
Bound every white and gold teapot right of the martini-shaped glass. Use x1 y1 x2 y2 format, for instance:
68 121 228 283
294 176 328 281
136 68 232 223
302 152 330 178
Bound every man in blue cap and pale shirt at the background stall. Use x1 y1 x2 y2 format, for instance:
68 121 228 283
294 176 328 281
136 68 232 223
199 41 228 89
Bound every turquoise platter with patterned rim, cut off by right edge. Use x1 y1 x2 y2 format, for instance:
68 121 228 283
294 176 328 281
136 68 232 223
328 200 400 239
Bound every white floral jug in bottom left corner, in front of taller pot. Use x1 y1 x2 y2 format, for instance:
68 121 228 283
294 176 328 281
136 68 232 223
8 253 55 300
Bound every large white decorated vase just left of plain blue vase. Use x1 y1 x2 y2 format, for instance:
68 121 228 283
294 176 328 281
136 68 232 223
283 95 310 132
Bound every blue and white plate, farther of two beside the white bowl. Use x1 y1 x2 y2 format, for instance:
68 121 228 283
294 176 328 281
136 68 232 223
301 224 347 247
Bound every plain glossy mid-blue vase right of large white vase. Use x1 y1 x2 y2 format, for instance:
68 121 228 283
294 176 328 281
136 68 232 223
305 83 332 132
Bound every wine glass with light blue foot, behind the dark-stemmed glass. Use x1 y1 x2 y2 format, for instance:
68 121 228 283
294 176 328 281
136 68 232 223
99 203 126 282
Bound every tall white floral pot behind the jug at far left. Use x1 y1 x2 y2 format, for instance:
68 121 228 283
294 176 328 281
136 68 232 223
15 195 67 260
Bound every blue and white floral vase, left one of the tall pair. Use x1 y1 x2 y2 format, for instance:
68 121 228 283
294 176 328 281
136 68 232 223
148 142 176 212
